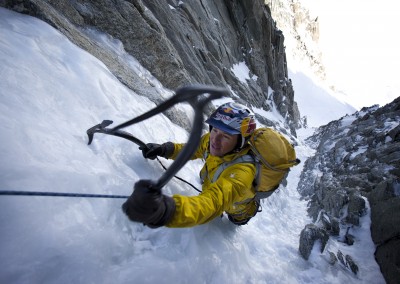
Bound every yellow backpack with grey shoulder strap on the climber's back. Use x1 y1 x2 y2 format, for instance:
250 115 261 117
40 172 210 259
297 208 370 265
213 127 300 200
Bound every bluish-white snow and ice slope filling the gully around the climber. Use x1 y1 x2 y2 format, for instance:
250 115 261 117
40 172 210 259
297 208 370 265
0 8 384 284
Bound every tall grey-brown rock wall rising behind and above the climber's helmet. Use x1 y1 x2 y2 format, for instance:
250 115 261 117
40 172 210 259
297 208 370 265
0 0 301 135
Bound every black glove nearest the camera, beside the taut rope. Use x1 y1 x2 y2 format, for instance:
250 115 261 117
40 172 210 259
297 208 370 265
122 180 176 228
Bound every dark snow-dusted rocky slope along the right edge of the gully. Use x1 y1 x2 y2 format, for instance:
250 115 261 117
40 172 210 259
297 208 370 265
299 97 400 283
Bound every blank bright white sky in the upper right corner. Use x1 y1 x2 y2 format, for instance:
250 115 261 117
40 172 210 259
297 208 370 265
301 0 400 109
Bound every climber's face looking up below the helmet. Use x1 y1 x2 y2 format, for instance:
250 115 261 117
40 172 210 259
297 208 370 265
210 127 239 157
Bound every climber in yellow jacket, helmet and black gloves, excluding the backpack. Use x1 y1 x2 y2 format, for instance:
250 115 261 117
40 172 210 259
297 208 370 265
122 103 259 228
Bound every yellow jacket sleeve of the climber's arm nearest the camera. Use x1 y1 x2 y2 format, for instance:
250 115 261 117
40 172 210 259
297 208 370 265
166 164 255 228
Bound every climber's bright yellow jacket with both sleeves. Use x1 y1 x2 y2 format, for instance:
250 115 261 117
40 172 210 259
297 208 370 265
166 133 257 228
